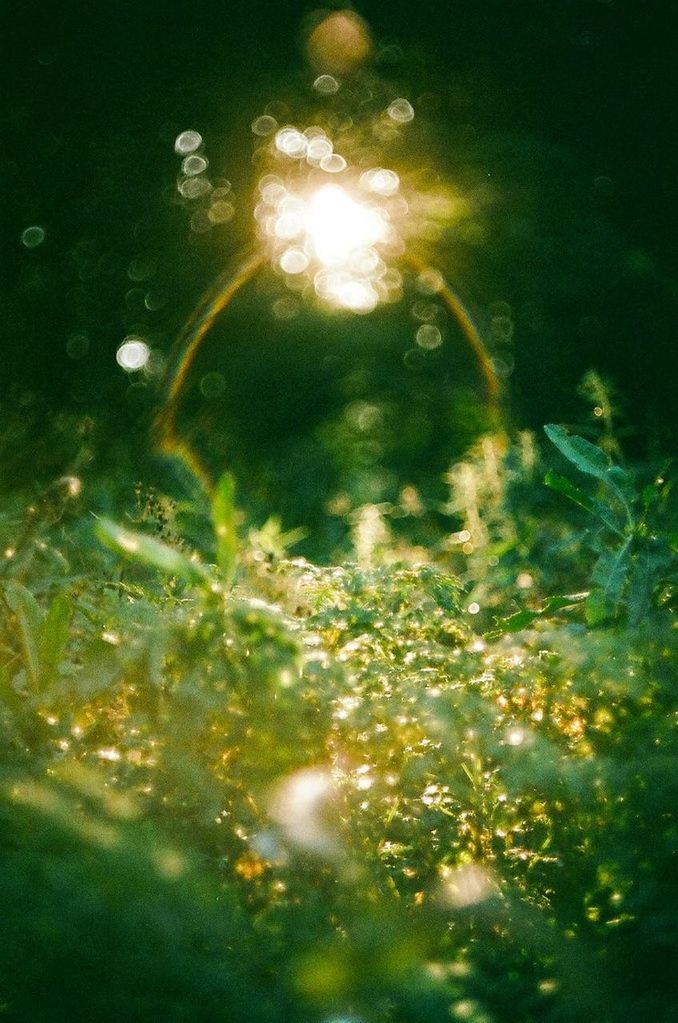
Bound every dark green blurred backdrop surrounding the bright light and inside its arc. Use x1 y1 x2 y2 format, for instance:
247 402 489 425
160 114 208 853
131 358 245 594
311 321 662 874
0 0 678 536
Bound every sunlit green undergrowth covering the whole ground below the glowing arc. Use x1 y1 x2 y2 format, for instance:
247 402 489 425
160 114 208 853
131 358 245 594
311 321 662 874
0 428 678 1023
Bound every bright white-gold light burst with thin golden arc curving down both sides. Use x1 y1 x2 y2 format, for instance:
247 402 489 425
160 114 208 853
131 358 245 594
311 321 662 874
155 115 501 492
